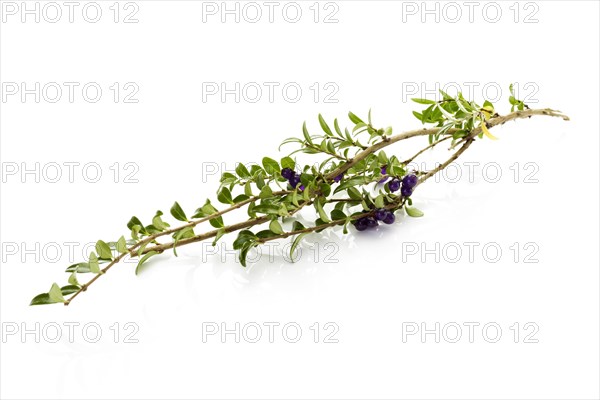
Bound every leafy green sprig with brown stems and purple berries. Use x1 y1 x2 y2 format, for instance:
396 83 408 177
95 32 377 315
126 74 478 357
31 85 569 305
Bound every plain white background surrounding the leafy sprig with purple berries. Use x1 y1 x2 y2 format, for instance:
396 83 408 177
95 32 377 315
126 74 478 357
0 1 599 399
